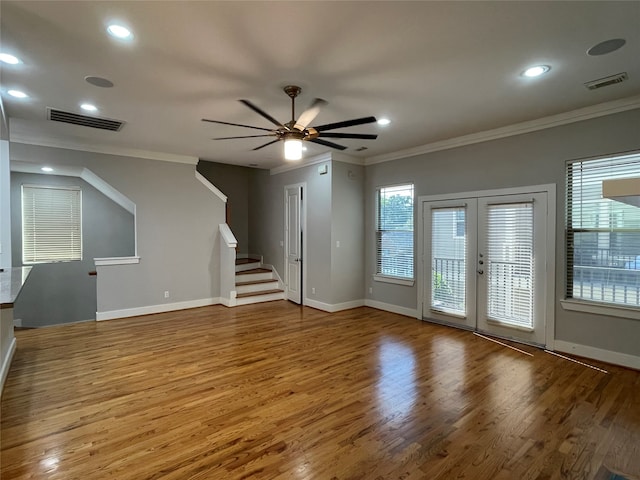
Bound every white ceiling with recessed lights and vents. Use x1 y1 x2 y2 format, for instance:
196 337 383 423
0 0 640 168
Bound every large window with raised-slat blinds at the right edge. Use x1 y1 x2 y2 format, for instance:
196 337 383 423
566 154 640 308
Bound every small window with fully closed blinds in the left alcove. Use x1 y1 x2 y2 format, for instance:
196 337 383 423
22 185 82 264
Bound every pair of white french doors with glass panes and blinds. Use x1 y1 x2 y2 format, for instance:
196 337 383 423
422 188 548 345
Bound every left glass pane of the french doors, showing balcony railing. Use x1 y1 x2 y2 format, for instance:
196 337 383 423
431 207 467 315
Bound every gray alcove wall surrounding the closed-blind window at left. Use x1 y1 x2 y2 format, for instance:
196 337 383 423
11 172 135 327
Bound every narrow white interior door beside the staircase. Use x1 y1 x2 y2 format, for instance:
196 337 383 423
284 185 303 304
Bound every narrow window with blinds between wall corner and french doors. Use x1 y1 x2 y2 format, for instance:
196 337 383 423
376 185 413 280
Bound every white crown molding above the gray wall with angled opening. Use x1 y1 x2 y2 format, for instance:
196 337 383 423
9 134 198 165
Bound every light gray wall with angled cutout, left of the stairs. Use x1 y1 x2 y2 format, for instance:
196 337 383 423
11 143 224 318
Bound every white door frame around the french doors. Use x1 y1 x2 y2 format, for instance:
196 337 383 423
416 183 556 350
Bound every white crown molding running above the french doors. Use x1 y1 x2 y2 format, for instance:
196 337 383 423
364 95 640 165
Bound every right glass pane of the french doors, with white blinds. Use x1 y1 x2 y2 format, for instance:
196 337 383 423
488 203 533 328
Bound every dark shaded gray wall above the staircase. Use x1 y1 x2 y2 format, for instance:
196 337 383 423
197 160 250 253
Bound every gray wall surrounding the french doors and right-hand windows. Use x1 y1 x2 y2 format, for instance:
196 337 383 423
365 109 640 355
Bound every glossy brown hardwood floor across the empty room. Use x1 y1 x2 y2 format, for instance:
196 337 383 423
1 301 640 480
